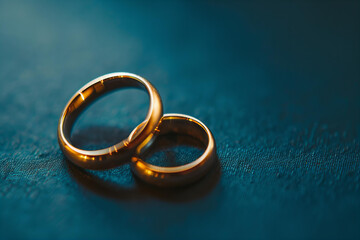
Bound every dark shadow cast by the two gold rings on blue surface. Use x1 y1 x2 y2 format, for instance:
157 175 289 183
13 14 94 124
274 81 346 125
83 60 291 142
64 126 221 202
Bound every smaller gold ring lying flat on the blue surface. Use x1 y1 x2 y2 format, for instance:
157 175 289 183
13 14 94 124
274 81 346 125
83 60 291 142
131 114 216 187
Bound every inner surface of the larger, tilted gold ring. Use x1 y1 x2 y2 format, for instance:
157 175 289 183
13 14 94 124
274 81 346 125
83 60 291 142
63 77 151 146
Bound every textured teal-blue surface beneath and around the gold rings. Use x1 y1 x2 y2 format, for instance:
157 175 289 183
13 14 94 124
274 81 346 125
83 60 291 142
0 0 360 239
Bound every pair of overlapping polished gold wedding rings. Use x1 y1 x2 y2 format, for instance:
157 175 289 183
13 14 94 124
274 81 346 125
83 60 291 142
58 72 216 186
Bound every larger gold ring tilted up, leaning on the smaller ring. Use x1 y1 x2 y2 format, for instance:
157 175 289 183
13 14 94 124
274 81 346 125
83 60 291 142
58 72 162 169
